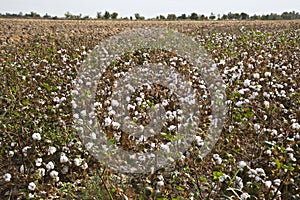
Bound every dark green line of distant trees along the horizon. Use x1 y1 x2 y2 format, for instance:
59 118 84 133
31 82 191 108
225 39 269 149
0 11 300 21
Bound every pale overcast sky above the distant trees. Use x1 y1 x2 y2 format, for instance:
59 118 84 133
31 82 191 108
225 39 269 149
0 0 300 18
